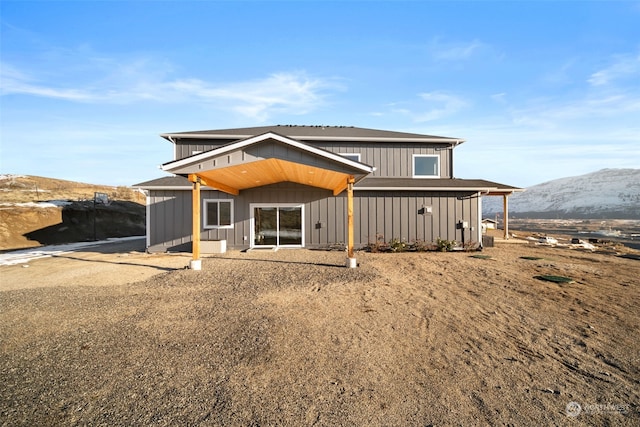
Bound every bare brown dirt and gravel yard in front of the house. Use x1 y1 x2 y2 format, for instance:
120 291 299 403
0 244 640 426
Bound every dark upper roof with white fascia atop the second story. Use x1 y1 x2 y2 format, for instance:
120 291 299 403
160 125 464 145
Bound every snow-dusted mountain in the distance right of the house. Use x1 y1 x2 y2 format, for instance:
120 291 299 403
483 169 640 219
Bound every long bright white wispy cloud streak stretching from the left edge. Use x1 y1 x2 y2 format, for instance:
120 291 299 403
0 60 341 121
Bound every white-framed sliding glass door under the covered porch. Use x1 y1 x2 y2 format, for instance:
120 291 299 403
251 204 304 247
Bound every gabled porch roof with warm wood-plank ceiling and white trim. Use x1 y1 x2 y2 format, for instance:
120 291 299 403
161 132 374 195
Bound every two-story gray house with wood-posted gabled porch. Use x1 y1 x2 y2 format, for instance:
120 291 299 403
134 125 521 268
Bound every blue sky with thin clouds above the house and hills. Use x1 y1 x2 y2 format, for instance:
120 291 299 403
0 0 640 187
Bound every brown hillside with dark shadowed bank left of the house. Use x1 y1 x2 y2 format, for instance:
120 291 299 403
0 175 146 250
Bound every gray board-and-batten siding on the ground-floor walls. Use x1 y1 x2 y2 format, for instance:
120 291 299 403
142 183 481 252
